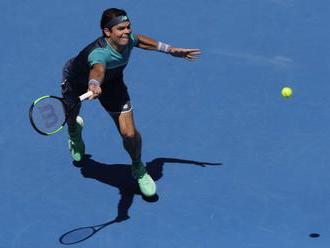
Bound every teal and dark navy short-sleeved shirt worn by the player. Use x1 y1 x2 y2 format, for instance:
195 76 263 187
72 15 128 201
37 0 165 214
63 34 138 88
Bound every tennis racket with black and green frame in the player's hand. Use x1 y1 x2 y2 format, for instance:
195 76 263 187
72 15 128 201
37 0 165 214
29 91 93 136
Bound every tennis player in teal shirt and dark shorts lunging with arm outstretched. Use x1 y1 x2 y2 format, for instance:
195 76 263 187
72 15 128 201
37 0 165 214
61 8 200 197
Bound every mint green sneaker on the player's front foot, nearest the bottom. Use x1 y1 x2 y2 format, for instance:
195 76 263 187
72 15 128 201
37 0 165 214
132 162 156 197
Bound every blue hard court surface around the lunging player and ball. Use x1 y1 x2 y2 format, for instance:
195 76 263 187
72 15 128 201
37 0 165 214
0 0 330 248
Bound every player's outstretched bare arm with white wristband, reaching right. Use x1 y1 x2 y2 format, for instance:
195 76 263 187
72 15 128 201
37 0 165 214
136 34 201 60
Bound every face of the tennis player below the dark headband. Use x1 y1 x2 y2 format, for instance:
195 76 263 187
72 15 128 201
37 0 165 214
109 21 132 46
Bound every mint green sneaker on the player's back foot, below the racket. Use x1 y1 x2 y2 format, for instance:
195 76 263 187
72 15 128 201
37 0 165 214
68 116 85 162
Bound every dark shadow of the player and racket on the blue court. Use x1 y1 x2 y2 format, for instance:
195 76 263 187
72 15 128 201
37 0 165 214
60 155 222 244
